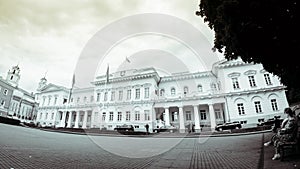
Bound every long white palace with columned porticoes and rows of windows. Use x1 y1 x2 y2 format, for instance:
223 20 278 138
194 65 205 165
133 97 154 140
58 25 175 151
36 59 289 132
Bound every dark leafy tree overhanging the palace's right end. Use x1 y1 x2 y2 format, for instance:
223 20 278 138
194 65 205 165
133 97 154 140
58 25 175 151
196 0 300 102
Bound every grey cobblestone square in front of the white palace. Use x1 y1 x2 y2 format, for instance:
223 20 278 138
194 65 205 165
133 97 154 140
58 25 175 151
0 123 264 169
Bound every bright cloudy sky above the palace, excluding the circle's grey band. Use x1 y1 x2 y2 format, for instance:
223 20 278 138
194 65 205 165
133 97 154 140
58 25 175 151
0 0 222 92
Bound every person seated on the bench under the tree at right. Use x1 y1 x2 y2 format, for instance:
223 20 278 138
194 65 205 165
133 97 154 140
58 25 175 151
272 108 298 160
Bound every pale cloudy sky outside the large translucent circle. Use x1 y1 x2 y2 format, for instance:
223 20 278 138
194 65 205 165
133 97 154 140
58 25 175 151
0 0 220 91
